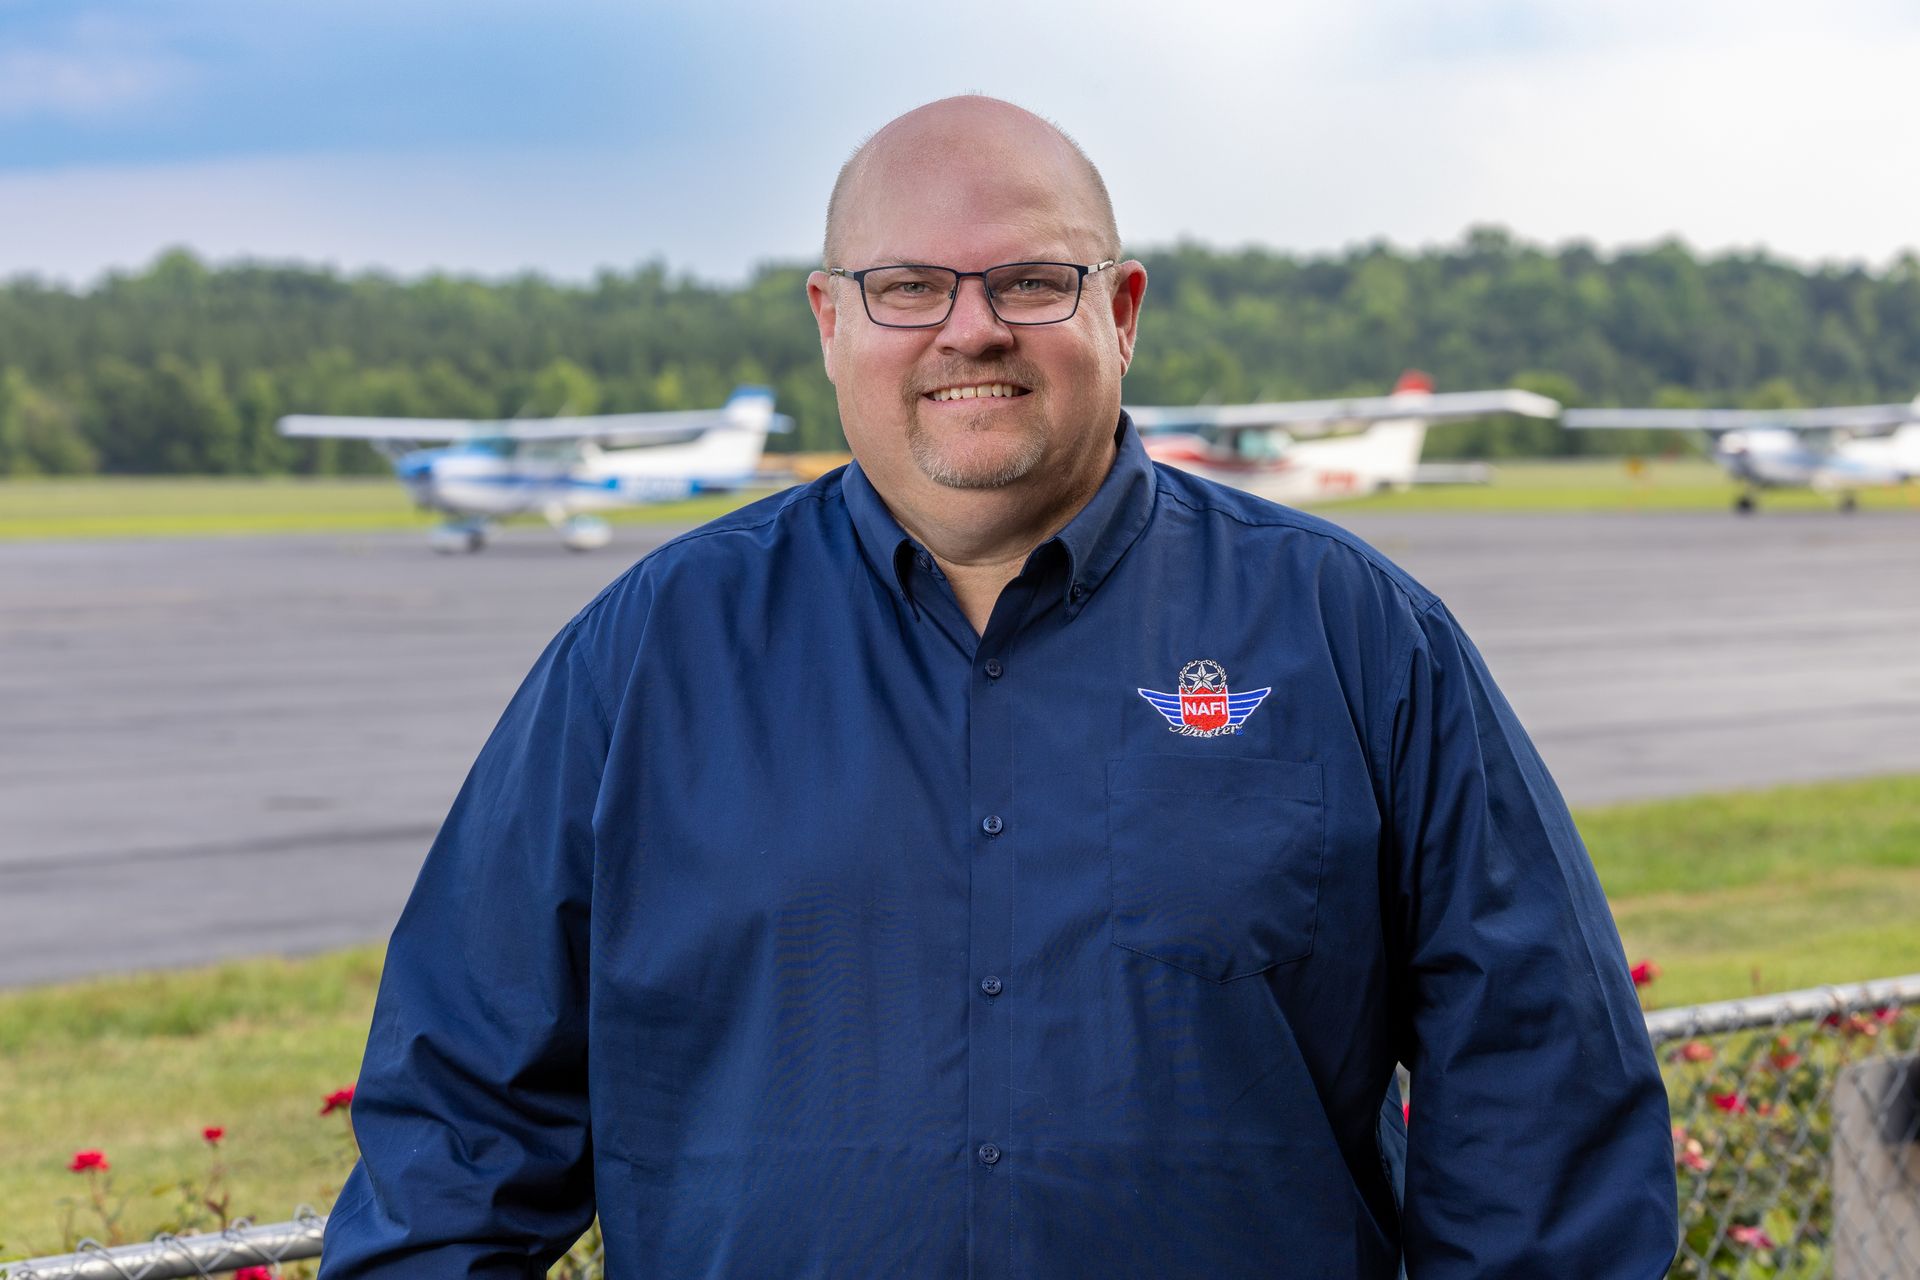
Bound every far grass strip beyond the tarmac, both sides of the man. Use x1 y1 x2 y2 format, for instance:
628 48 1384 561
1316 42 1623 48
0 461 1920 541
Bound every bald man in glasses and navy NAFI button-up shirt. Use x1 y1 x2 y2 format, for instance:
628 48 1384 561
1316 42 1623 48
323 98 1674 1280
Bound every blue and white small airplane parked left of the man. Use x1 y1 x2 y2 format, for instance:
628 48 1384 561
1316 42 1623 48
278 386 793 553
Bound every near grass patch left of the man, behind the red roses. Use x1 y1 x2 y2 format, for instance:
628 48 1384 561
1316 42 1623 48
0 948 380 1259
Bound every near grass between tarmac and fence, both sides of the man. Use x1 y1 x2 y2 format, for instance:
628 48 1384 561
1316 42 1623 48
0 775 1920 1257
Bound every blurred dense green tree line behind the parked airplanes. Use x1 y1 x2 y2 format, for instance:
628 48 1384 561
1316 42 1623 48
0 226 1920 476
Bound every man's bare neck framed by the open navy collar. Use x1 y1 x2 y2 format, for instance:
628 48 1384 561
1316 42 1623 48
883 451 1117 635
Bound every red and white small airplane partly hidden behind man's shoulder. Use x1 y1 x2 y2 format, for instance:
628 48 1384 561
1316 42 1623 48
1127 370 1561 503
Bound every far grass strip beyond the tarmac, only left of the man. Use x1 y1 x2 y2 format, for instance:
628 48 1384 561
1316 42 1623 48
0 476 758 541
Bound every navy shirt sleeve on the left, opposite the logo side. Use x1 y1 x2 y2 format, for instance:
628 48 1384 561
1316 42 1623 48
321 620 609 1280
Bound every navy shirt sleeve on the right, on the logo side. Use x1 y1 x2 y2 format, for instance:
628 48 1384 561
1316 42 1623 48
1386 604 1678 1280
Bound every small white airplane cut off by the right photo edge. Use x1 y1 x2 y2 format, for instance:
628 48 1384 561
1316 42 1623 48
1561 397 1920 514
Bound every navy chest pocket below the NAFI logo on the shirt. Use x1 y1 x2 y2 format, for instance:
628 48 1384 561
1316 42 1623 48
1106 756 1327 983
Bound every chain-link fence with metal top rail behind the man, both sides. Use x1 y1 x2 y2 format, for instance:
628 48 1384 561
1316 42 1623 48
0 975 1920 1280
